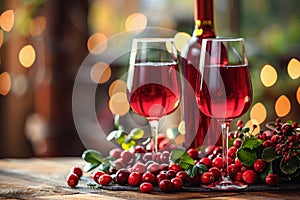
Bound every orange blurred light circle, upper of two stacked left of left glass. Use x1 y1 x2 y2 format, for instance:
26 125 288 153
87 33 107 54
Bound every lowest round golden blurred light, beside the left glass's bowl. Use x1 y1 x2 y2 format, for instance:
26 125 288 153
108 92 130 116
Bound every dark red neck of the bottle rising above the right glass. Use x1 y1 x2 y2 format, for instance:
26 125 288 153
193 0 215 38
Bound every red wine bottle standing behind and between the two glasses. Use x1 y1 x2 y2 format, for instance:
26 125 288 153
182 0 221 148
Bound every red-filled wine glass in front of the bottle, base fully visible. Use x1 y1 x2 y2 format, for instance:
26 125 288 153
196 38 252 190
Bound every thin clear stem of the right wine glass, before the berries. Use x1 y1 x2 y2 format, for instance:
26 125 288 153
220 120 231 181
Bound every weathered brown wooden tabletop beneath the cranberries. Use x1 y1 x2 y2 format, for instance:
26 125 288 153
0 158 300 200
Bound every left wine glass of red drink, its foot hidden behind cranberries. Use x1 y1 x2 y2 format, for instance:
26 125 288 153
127 38 181 155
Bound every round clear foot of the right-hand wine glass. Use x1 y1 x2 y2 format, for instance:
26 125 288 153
202 180 248 190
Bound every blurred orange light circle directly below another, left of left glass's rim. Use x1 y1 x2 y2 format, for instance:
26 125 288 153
90 62 111 84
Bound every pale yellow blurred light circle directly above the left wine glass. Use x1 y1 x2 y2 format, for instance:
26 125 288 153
125 13 147 34
